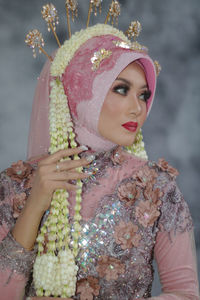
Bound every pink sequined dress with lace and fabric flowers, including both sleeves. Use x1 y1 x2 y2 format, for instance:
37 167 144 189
0 148 199 300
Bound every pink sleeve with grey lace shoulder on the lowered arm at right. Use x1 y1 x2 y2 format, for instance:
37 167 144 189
137 176 200 300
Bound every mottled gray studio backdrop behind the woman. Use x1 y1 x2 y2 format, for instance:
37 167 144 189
0 0 200 294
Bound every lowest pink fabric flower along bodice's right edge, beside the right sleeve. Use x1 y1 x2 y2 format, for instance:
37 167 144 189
135 201 160 227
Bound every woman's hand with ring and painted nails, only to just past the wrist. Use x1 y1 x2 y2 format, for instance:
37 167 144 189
28 146 94 213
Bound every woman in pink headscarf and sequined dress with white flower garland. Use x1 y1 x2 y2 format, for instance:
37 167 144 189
0 18 199 300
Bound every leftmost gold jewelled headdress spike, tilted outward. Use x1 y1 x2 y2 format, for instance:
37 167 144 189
25 29 53 61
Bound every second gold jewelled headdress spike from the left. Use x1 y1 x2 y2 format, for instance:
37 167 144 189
41 3 61 47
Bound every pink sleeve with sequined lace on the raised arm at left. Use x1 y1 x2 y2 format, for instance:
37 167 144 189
0 172 35 300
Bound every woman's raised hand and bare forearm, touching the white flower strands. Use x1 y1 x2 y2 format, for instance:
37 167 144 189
12 147 94 250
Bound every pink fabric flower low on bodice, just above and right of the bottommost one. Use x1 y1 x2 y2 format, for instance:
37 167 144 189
96 255 125 280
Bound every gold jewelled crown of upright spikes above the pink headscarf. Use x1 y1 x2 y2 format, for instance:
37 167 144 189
25 0 161 75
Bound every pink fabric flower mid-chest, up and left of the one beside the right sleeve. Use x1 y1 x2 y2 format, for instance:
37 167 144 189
118 182 140 206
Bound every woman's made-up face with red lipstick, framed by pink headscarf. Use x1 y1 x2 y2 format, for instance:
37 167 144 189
98 62 151 146
